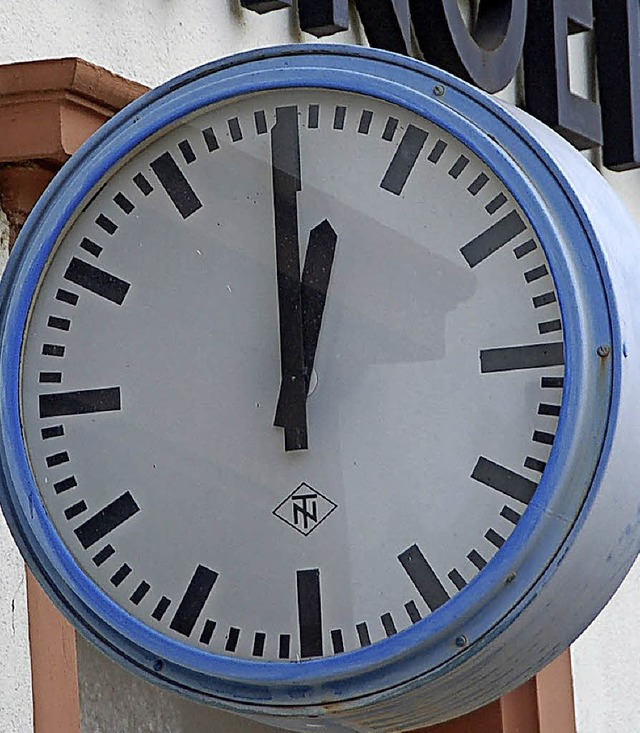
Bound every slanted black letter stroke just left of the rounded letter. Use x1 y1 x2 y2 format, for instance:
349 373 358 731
356 0 411 56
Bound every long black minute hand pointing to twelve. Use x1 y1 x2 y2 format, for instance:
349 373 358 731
271 106 307 451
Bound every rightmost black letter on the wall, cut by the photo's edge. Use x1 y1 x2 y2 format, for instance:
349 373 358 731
593 0 640 171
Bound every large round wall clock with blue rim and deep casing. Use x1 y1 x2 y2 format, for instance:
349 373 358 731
0 46 640 730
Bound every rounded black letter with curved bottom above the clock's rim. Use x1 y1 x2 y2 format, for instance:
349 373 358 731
409 0 537 92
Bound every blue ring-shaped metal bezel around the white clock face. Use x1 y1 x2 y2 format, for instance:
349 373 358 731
0 45 622 711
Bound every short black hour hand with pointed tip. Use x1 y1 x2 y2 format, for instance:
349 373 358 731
274 219 338 425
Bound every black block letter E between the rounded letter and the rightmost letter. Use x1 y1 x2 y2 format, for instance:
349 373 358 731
524 0 604 149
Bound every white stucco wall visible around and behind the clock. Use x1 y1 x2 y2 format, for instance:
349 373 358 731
0 0 640 733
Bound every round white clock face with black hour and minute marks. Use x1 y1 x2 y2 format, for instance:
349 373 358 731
21 89 564 661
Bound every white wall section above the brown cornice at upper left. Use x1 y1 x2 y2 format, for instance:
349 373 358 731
0 0 361 86
